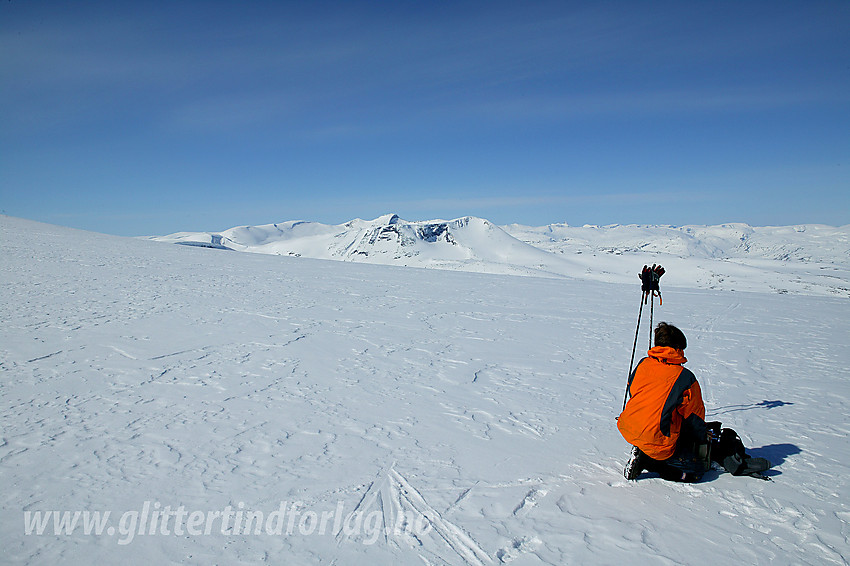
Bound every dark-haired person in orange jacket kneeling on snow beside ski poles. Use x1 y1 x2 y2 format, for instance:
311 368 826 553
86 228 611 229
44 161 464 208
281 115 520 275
617 322 770 482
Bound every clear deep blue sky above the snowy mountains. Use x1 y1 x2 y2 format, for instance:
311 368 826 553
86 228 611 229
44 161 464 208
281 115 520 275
0 0 850 235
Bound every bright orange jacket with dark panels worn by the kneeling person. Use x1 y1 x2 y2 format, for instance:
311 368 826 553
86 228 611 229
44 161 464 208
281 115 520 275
617 346 705 460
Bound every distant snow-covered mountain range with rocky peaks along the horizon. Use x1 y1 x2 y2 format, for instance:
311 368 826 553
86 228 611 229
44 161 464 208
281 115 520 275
147 214 850 296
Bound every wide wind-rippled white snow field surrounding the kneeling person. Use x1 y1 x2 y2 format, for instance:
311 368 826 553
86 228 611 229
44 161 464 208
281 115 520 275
0 216 850 565
